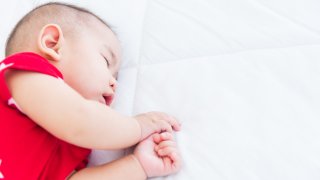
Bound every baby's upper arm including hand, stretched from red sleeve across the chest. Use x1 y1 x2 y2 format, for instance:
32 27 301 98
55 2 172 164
6 71 179 149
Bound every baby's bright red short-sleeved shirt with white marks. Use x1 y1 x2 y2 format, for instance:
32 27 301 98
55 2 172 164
0 52 90 180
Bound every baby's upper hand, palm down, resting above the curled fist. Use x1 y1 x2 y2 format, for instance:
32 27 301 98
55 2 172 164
134 112 181 140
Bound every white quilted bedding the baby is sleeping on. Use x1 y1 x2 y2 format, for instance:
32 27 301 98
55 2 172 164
0 0 320 180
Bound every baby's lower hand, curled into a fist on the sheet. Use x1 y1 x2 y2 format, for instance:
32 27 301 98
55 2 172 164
134 132 182 177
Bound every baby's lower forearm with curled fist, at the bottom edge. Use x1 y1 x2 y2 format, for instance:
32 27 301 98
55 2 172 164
70 133 182 180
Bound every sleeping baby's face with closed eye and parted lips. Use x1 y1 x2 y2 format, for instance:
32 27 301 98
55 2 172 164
60 21 120 105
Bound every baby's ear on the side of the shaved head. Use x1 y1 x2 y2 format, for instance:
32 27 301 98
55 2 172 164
38 24 64 61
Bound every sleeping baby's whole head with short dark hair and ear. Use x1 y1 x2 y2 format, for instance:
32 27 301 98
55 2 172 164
6 3 120 105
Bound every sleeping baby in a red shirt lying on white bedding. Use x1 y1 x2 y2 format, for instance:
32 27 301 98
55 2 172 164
0 3 181 180
